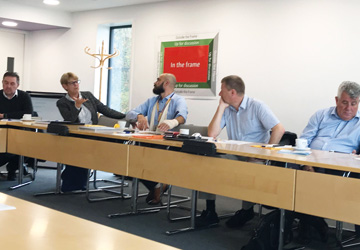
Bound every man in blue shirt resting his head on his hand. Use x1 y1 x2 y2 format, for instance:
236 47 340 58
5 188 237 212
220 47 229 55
196 75 285 228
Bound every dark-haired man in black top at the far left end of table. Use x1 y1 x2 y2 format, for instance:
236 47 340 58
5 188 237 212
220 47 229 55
0 72 33 180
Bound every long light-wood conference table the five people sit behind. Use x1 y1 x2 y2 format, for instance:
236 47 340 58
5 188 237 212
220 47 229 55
0 122 360 248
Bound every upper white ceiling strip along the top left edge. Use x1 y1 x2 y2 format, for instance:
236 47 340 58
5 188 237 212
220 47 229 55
5 0 168 12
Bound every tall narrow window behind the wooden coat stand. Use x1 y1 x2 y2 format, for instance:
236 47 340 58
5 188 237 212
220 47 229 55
107 25 131 112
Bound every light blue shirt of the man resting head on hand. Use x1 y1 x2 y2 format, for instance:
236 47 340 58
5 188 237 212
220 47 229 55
220 95 280 143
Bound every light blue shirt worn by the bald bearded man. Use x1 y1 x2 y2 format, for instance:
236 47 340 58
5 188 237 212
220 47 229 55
126 92 188 126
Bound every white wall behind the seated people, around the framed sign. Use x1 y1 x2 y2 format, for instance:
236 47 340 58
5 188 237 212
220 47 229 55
21 0 360 136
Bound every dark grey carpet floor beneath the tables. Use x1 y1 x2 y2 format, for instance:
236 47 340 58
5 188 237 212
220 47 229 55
0 162 357 250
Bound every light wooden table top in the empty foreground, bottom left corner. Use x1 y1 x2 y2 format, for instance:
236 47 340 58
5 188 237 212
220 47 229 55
0 193 177 250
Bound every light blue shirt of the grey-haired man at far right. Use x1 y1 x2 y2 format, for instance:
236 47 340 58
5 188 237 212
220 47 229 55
300 107 360 154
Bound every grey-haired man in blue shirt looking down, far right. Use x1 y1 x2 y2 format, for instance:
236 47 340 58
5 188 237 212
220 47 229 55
300 81 360 241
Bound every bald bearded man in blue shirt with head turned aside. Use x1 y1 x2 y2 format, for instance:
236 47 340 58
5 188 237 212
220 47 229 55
126 73 188 205
